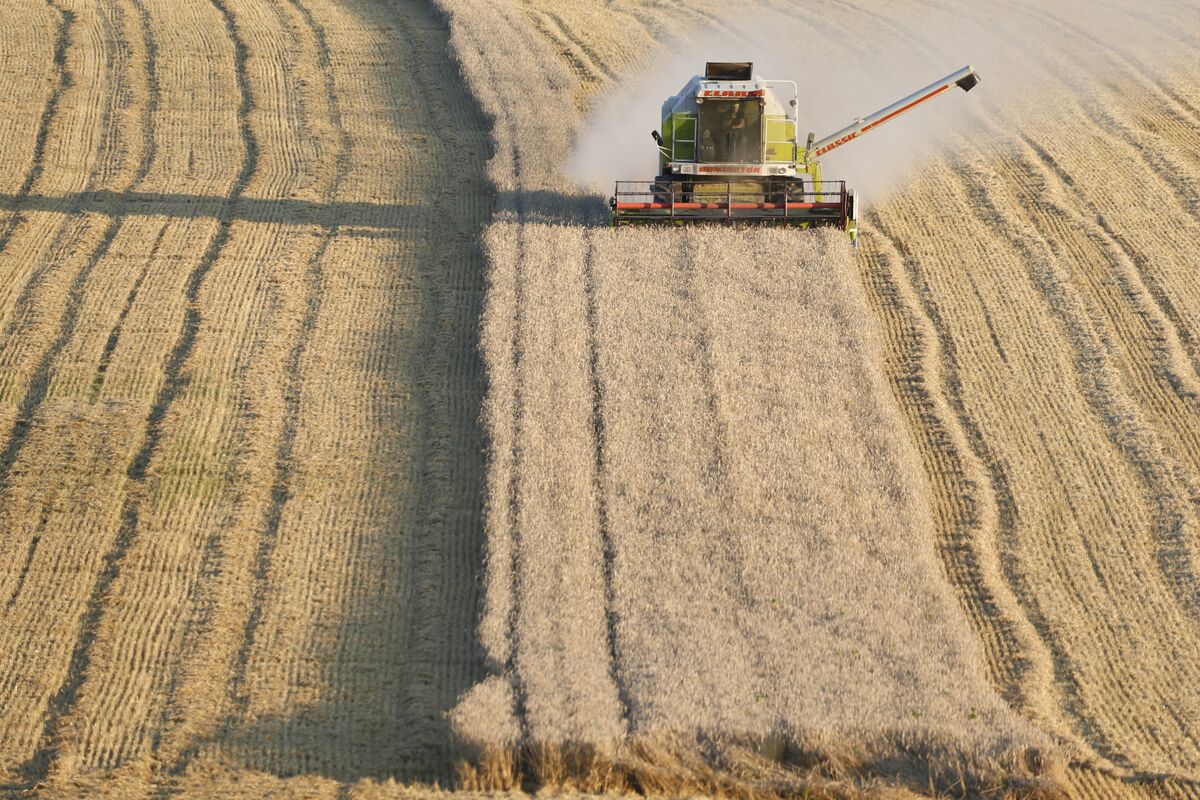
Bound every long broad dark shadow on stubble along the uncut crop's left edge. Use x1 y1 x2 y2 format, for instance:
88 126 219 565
261 0 496 786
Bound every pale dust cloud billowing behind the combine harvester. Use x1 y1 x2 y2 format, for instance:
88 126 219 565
568 0 1200 205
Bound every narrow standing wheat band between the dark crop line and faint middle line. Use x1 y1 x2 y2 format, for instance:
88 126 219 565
594 225 767 734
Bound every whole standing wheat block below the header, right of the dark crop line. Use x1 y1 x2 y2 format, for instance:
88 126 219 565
588 225 1037 754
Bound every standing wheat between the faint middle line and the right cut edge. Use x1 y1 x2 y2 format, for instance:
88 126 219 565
694 226 1037 753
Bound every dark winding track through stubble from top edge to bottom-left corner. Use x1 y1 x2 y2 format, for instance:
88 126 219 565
22 0 258 784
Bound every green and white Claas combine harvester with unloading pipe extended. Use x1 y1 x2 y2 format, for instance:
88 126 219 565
611 61 979 245
